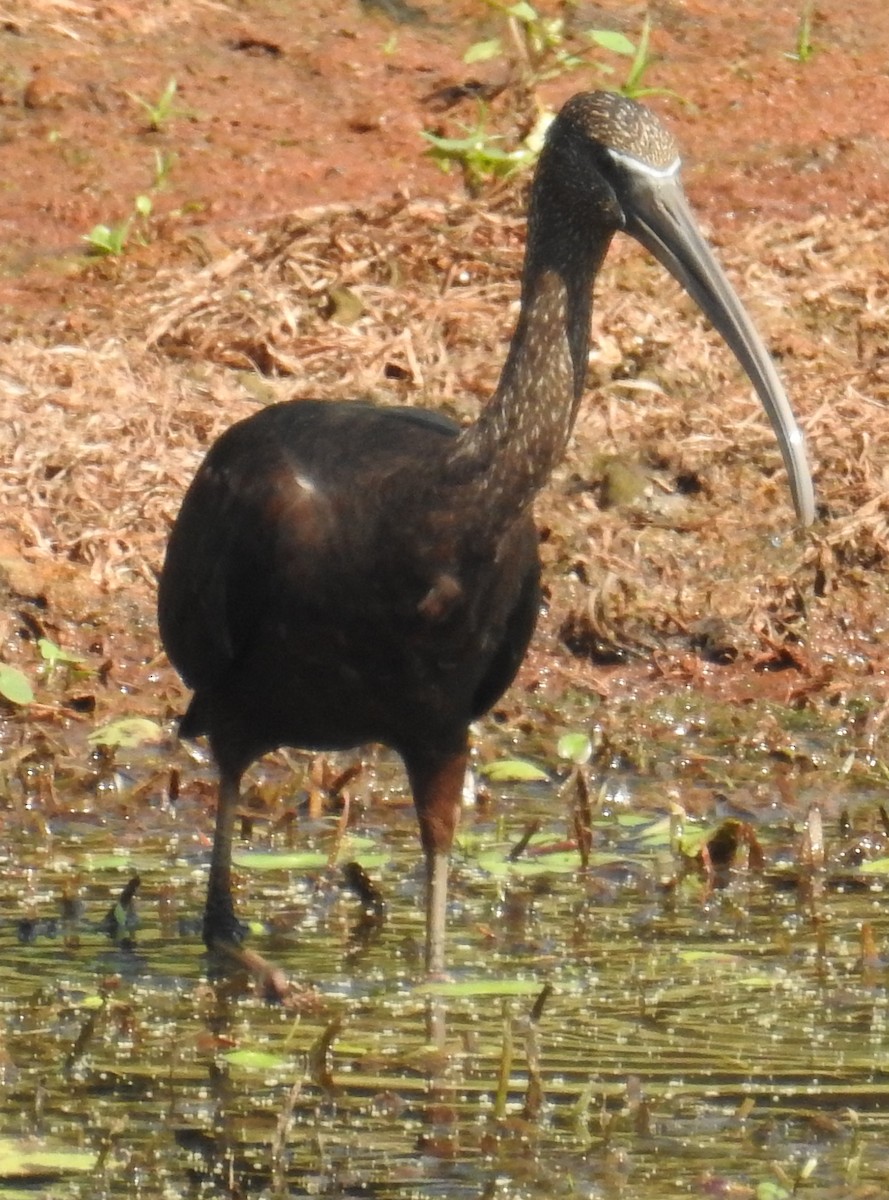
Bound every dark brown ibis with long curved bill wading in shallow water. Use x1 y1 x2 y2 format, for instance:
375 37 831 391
160 92 813 973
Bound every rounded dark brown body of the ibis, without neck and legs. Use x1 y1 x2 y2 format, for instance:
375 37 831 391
158 401 539 764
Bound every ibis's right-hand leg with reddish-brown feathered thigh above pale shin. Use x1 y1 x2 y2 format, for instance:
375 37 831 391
407 744 469 978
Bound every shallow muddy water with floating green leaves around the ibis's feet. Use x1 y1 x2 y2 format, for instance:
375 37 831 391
0 748 889 1200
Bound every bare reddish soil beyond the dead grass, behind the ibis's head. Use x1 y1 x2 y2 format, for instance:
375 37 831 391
0 0 889 300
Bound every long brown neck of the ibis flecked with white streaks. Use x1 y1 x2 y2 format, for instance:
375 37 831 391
443 209 611 526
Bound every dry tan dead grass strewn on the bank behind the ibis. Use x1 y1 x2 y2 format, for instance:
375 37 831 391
0 193 889 705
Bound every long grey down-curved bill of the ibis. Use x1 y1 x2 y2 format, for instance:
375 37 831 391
624 162 815 526
